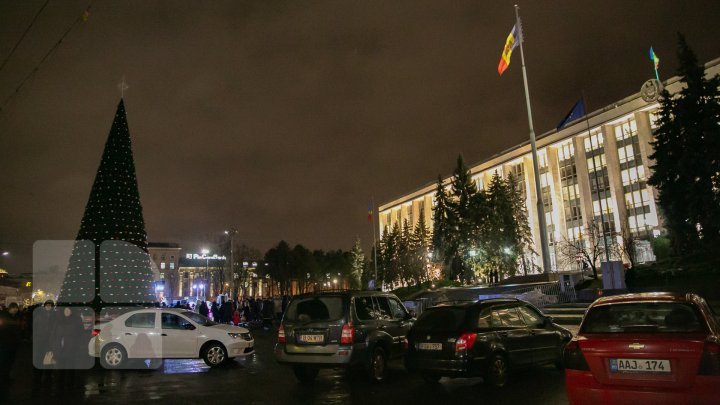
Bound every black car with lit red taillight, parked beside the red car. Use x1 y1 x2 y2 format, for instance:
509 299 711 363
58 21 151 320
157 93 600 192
406 298 572 387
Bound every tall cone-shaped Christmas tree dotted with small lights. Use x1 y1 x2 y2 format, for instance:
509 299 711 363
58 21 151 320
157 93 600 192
58 99 154 310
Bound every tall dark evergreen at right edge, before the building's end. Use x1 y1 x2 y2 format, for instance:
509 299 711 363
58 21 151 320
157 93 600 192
649 34 720 254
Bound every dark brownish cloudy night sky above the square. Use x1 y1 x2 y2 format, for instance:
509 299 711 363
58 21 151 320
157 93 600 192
0 0 720 272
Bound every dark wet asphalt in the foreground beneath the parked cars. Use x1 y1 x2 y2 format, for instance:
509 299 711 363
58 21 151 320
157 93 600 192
0 329 567 405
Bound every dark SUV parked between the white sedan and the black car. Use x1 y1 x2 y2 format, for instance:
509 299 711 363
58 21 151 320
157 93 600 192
275 291 413 382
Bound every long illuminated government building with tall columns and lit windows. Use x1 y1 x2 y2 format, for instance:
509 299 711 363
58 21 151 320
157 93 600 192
378 58 720 270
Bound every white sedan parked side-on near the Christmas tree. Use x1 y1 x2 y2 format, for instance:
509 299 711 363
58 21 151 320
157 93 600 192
88 308 255 369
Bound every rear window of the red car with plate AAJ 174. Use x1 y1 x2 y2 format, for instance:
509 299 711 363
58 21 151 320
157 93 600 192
580 302 705 333
